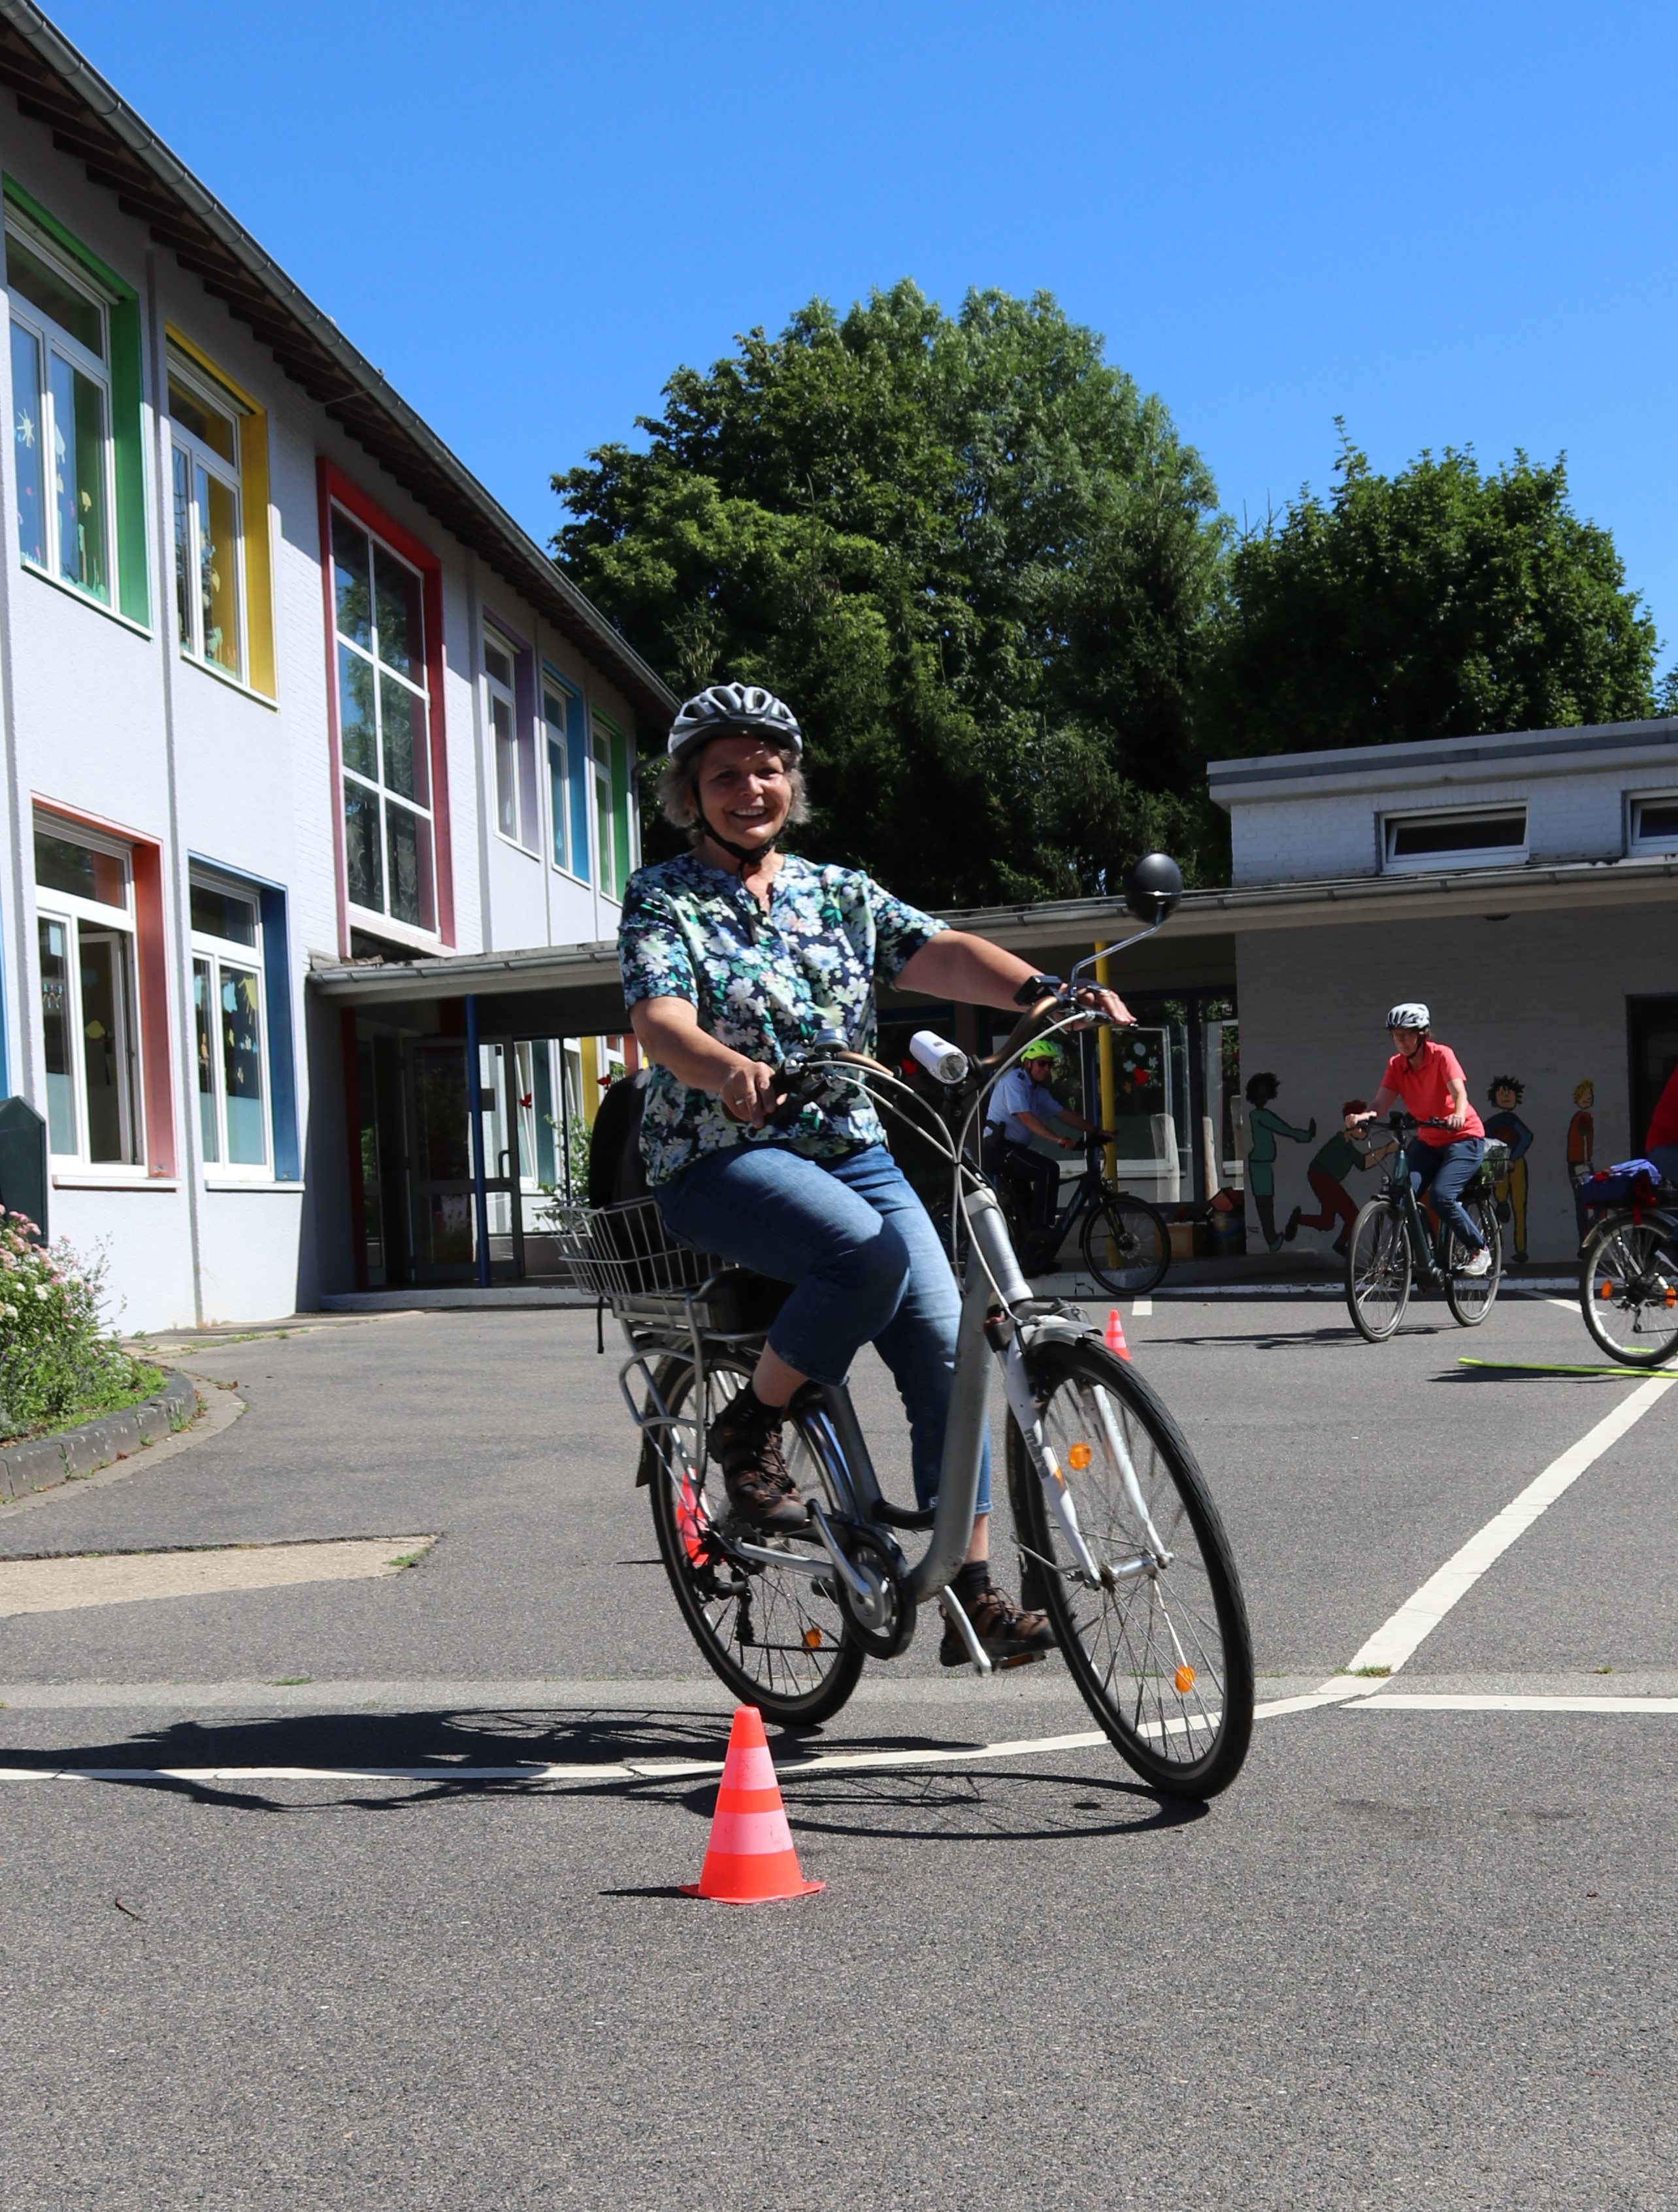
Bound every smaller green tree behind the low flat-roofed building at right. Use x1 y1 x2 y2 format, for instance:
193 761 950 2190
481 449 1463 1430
1200 429 1656 758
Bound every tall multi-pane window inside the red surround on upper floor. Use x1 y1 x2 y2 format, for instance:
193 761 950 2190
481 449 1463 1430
332 506 436 934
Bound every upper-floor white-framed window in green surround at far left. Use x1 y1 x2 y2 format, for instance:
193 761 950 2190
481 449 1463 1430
7 225 115 606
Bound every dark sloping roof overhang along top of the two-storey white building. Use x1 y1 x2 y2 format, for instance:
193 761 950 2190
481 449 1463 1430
0 0 678 723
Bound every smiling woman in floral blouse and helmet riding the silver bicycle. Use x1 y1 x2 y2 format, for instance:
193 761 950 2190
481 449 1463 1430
617 683 1131 1666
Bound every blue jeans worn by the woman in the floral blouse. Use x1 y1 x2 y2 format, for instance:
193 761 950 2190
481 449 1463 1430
653 1144 989 1513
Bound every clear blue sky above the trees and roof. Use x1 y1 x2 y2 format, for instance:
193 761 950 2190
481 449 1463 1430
42 0 1678 659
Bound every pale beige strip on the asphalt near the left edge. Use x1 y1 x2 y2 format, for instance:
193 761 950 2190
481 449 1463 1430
0 1535 436 1619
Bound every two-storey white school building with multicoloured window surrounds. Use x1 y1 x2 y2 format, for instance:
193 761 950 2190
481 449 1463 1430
0 0 675 1329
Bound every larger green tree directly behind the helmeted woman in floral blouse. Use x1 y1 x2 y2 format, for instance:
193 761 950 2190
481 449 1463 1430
553 283 1224 905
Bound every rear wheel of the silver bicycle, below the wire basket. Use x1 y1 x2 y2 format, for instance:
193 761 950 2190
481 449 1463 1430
642 1358 863 1727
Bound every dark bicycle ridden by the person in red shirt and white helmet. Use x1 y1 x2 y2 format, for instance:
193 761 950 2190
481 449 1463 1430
1346 1113 1507 1345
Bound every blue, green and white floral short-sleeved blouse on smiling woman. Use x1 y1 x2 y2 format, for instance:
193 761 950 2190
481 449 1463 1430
617 854 946 1188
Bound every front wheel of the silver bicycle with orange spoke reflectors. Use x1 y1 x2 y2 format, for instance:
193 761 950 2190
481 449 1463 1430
1007 1336 1253 1803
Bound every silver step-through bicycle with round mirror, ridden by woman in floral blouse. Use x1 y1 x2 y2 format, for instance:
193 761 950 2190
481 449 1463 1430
563 854 1253 1798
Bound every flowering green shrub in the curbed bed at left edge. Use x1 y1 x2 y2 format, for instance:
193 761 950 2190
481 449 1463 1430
0 1212 157 1438
